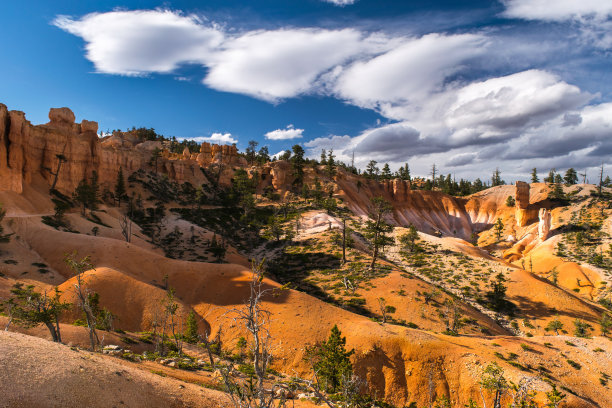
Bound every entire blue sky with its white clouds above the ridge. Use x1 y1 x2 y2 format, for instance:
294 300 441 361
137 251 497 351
0 0 612 181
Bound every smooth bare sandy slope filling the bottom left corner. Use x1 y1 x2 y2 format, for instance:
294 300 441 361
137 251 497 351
0 331 227 408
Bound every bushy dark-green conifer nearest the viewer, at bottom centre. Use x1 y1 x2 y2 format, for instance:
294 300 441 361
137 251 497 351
306 325 355 393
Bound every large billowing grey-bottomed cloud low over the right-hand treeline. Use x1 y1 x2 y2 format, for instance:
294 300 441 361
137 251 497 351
305 70 592 174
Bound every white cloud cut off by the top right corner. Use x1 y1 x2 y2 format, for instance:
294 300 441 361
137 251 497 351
504 0 612 21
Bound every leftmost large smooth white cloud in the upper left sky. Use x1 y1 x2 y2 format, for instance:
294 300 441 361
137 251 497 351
54 10 223 75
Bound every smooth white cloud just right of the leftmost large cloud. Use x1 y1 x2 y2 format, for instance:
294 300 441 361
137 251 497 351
204 29 388 102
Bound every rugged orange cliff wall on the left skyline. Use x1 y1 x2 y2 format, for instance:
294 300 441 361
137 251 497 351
0 104 220 194
